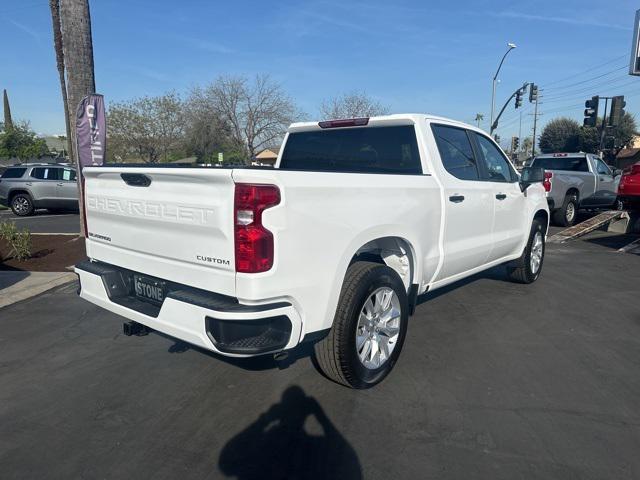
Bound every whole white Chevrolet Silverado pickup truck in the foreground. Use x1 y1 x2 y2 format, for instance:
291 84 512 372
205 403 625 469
75 114 549 388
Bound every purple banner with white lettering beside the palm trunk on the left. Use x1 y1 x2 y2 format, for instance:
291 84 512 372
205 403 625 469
76 93 107 168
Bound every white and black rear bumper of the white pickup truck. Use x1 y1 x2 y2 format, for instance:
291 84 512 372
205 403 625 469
75 261 302 357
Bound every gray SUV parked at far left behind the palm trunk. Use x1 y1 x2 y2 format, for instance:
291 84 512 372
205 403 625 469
0 163 78 217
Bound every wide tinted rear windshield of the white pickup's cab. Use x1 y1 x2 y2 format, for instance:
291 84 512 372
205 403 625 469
280 125 422 174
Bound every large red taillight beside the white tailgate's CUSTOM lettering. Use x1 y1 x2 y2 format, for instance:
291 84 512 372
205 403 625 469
233 183 280 273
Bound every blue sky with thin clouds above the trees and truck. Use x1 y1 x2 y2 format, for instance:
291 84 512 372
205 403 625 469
0 0 640 145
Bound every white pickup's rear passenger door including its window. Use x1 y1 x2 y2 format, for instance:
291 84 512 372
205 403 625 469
431 124 494 281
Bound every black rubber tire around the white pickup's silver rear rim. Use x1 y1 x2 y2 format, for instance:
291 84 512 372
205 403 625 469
315 262 409 389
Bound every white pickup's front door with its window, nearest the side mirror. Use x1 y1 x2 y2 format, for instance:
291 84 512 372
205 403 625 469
472 132 529 261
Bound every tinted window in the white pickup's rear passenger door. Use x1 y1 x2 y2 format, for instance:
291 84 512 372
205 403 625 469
431 125 480 180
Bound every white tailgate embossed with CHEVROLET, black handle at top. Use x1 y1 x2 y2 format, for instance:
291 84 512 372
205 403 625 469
83 167 235 296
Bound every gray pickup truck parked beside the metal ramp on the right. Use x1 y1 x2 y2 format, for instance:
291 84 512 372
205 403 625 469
531 152 622 227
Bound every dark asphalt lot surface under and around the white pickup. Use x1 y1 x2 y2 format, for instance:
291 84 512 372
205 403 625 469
0 232 640 480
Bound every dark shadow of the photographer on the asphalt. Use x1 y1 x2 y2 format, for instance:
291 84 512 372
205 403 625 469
218 386 362 480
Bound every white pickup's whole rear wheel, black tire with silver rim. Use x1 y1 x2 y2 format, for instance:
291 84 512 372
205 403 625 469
315 262 409 388
